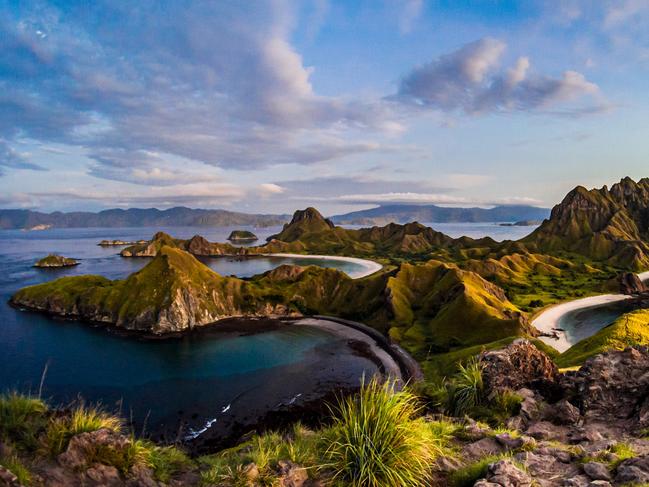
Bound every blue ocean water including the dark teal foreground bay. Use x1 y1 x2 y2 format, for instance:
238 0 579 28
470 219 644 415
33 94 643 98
0 224 536 446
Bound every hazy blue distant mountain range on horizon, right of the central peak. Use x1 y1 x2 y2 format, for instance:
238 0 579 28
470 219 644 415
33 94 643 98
331 205 550 225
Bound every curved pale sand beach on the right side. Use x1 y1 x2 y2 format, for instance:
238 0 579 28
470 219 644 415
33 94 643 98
531 271 649 353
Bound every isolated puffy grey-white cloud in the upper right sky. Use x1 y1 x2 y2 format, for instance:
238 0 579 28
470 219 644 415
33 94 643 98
393 38 607 114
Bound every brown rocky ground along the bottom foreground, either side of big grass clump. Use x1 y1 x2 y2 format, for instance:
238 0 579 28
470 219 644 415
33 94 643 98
0 346 649 487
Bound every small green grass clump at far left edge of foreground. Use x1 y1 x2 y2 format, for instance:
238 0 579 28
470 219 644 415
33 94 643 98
0 392 47 449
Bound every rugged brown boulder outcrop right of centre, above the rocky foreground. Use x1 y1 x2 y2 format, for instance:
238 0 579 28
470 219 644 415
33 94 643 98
480 339 559 394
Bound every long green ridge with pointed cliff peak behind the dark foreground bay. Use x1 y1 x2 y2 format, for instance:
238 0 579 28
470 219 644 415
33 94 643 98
11 246 530 352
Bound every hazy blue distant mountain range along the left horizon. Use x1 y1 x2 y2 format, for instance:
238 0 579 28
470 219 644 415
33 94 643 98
0 207 290 230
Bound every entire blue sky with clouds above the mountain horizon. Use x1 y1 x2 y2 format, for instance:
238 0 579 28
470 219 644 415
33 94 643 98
0 0 649 214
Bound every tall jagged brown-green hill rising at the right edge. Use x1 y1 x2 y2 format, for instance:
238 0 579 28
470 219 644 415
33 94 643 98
523 178 649 270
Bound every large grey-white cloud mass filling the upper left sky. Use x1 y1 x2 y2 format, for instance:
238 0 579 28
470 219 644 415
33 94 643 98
0 0 400 176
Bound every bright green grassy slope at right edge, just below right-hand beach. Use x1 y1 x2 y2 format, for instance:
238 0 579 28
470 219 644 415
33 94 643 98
556 310 649 367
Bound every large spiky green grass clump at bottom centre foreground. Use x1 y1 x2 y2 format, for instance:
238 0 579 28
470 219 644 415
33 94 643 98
324 379 438 487
